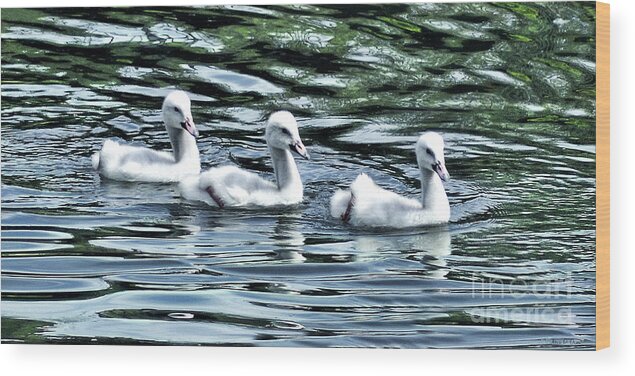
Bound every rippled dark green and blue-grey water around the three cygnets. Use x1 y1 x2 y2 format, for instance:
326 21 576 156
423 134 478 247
2 3 595 349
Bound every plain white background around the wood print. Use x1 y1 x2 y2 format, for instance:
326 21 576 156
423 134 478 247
0 0 635 376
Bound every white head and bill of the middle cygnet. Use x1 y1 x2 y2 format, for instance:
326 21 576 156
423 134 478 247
265 111 310 159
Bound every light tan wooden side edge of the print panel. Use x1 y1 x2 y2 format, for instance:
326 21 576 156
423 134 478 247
595 2 611 350
